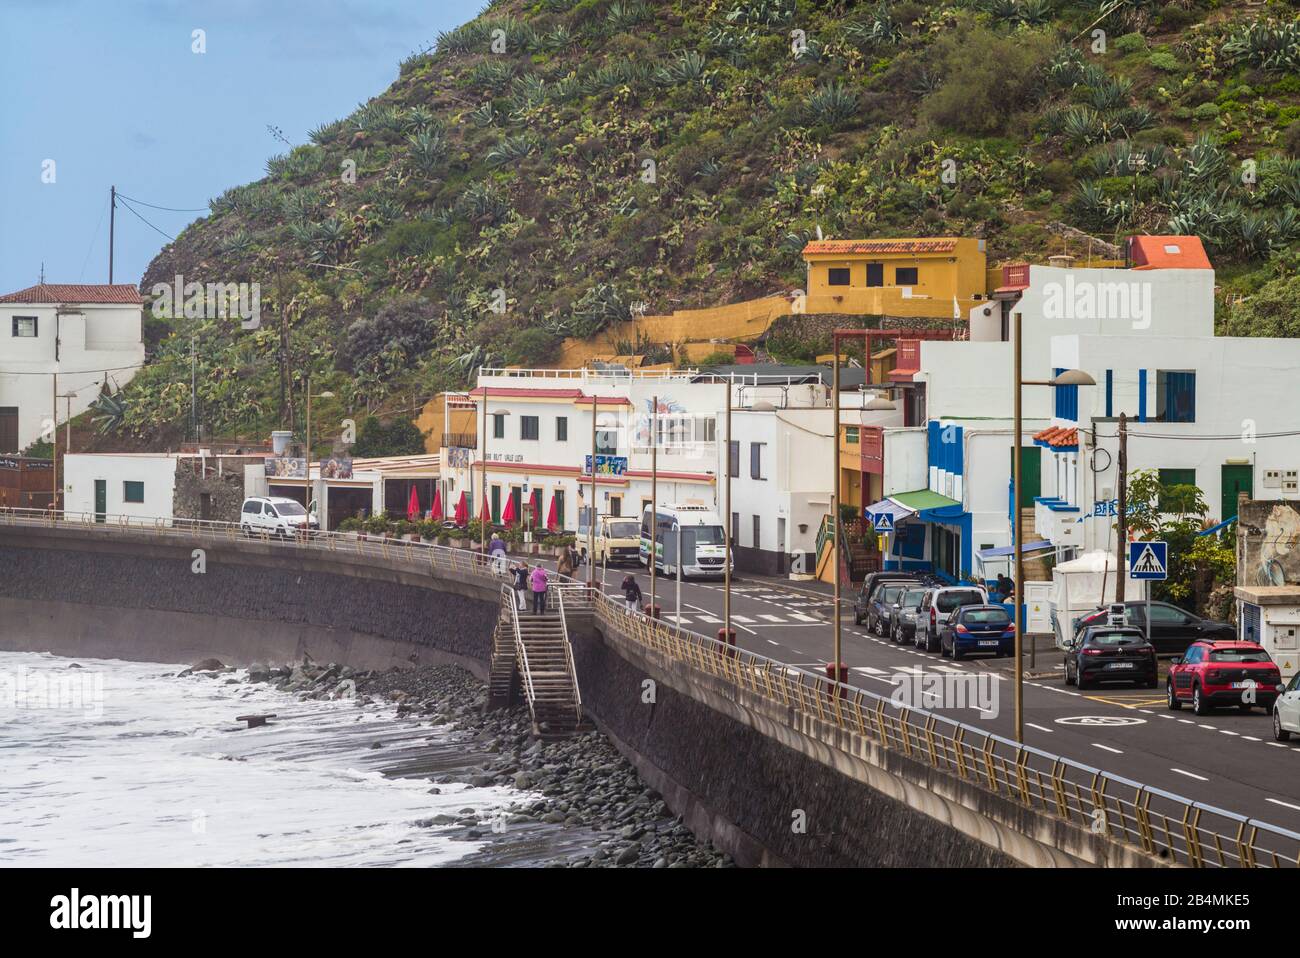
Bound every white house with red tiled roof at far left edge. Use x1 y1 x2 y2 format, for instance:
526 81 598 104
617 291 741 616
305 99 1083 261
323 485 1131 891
0 283 144 452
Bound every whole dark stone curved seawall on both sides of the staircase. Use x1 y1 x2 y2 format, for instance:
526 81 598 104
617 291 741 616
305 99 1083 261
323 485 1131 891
0 525 1158 867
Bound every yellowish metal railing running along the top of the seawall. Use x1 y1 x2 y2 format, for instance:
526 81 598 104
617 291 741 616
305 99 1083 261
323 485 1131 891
0 510 1300 868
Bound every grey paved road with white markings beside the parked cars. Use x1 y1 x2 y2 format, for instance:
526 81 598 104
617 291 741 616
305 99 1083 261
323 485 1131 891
540 556 1300 831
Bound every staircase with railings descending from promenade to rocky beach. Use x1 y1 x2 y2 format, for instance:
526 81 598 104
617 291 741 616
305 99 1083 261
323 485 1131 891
489 586 582 736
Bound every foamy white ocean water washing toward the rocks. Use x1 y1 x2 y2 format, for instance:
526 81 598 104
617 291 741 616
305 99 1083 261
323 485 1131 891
0 653 529 867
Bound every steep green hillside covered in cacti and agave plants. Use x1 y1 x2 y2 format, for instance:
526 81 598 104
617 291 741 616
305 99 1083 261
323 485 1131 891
114 0 1300 442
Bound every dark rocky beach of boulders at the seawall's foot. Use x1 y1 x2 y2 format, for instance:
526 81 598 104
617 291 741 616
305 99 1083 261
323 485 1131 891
201 659 733 868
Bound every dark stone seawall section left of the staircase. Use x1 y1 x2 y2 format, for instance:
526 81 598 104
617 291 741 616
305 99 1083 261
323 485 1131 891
0 526 497 677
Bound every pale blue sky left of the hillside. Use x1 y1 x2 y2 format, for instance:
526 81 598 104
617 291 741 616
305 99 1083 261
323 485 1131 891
0 0 484 292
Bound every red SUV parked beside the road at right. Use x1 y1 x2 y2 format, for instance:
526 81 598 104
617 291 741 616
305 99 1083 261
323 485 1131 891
1166 640 1282 715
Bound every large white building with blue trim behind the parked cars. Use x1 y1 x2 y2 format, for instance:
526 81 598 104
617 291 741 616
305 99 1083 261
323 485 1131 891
868 237 1300 577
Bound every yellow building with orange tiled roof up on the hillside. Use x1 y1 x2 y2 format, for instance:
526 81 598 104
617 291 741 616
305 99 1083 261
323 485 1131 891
803 237 988 320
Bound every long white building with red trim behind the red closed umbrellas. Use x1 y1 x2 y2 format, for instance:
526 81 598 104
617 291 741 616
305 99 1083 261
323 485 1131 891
452 367 902 575
